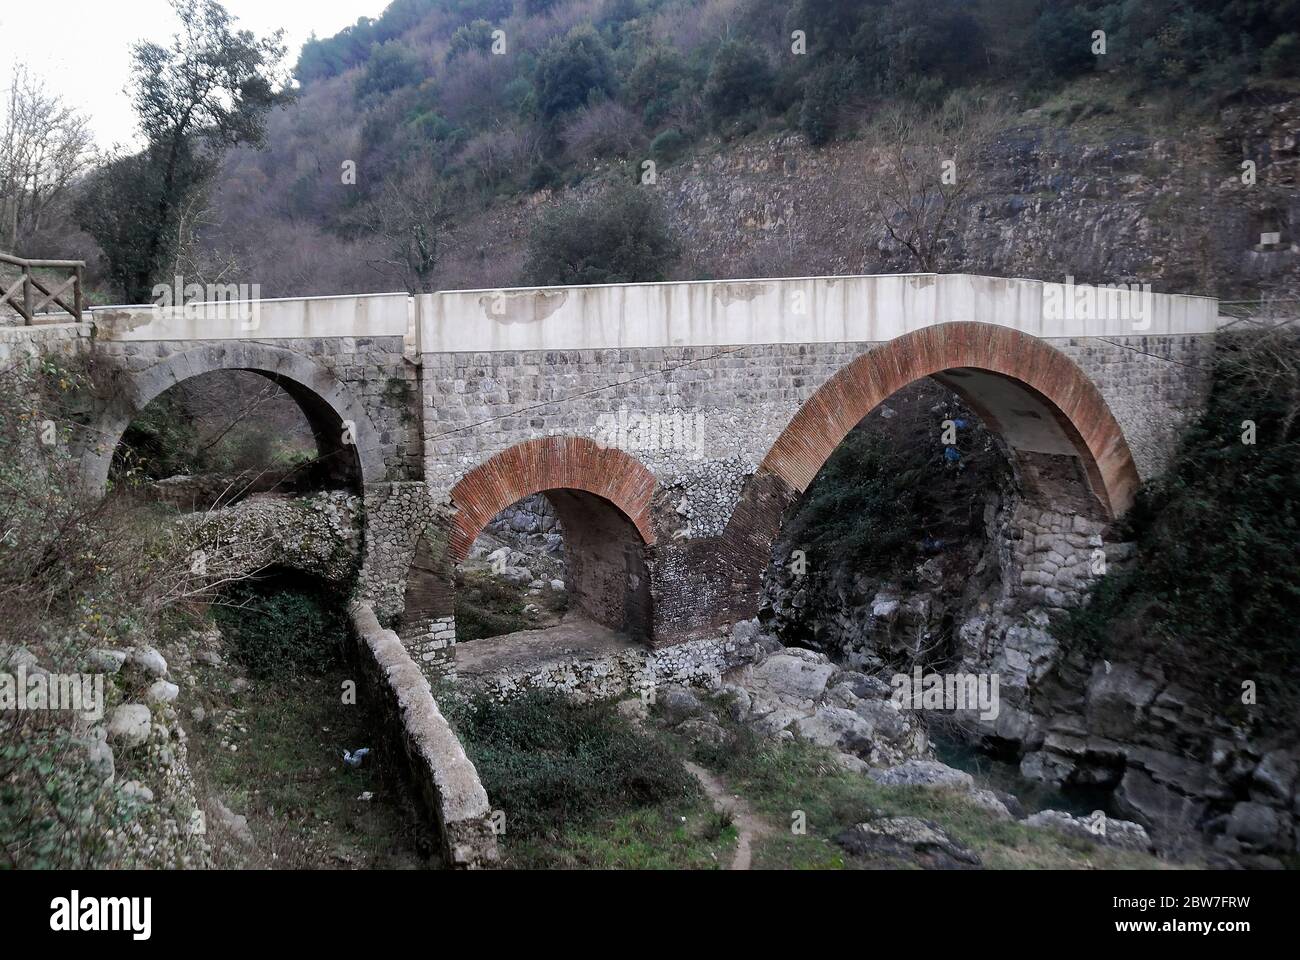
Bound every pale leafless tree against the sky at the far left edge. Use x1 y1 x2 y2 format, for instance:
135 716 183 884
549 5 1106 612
0 64 92 250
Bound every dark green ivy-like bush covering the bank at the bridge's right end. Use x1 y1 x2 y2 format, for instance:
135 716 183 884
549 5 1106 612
1057 333 1300 727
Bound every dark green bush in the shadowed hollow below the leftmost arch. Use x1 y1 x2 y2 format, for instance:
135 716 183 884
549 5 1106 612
213 575 347 676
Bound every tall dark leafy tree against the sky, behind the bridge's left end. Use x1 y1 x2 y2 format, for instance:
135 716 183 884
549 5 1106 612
78 0 289 302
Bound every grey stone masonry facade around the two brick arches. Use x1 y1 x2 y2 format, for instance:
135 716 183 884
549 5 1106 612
421 336 1210 504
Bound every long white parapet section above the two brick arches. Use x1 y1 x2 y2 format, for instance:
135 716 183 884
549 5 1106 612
416 273 1218 353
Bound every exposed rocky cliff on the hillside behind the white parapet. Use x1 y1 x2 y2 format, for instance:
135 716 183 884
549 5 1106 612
443 100 1300 297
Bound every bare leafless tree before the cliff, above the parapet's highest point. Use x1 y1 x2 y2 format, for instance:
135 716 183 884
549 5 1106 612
863 98 1010 273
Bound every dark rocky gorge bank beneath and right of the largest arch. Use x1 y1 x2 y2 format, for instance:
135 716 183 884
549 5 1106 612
763 379 1300 862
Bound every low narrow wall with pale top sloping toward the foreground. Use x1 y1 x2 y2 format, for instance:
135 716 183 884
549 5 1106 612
351 604 499 869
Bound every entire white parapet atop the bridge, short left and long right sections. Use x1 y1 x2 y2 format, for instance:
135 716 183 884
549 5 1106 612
78 273 1219 359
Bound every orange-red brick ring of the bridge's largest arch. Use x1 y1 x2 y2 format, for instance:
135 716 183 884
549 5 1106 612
759 323 1139 515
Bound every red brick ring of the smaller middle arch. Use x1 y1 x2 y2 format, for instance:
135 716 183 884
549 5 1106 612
450 437 655 563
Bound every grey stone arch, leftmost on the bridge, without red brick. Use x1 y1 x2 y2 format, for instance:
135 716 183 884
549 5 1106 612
82 341 386 494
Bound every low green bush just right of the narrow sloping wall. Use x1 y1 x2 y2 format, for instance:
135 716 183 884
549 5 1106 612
452 691 697 836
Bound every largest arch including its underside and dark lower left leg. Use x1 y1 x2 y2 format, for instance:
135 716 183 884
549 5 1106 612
723 321 1139 596
